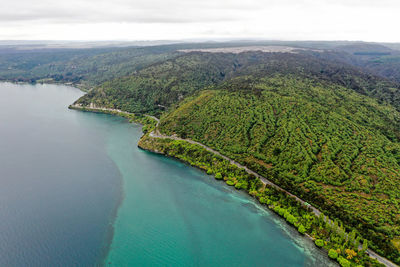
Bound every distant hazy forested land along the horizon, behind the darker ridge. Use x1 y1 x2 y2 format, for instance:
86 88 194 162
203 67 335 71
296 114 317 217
0 41 400 92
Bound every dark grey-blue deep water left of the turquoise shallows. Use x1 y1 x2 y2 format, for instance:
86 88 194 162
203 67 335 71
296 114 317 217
0 84 121 266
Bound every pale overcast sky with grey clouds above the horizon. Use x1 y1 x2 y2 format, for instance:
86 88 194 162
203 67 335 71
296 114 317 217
0 0 400 42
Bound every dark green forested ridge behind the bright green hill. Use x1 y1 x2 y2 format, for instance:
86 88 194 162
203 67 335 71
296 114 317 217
77 51 400 114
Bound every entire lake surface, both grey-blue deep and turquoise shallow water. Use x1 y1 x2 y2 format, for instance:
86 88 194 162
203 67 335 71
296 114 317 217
0 84 333 266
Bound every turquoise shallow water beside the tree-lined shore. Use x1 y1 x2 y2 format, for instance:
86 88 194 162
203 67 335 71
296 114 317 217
105 125 335 266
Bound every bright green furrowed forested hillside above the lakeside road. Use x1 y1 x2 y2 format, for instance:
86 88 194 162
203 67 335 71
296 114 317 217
159 75 400 258
